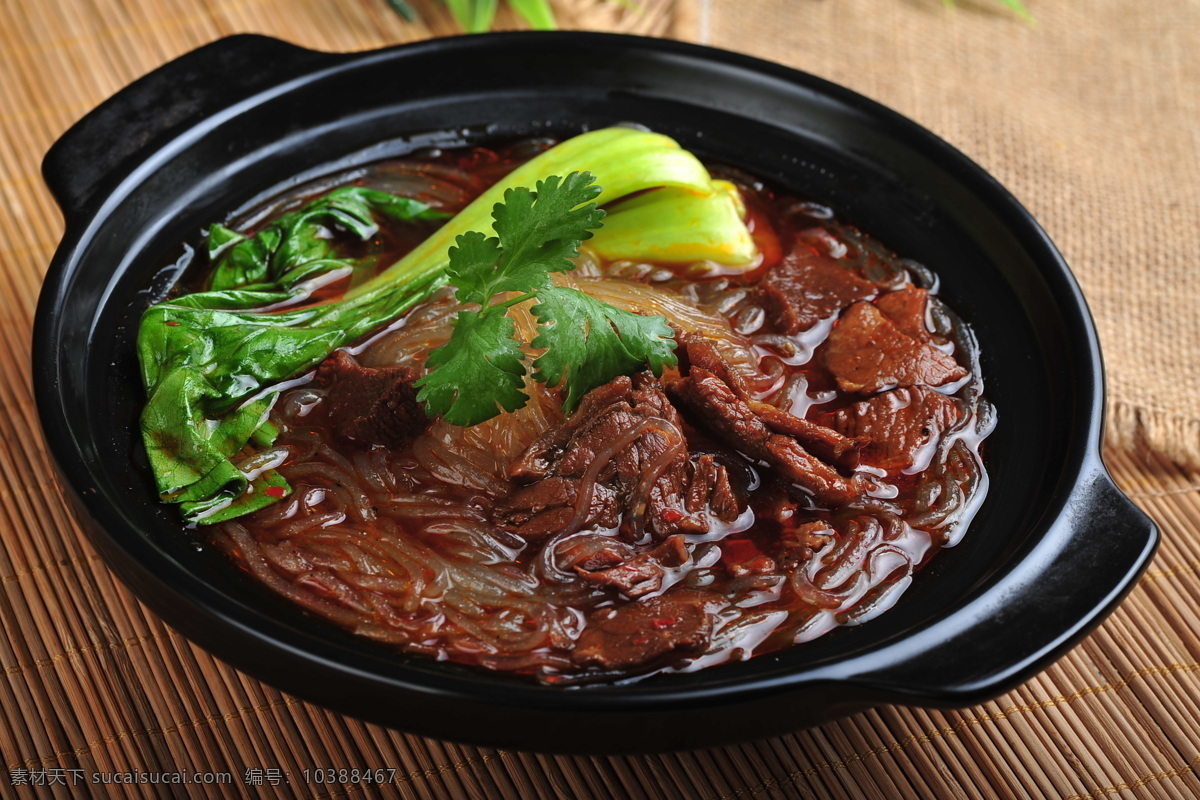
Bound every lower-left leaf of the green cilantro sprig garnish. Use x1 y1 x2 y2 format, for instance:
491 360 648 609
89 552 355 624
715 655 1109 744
414 309 529 426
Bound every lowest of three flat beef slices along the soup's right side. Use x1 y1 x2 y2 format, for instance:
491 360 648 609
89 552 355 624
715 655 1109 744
830 386 961 470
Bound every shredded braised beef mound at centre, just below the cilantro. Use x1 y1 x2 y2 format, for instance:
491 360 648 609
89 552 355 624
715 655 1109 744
492 373 737 541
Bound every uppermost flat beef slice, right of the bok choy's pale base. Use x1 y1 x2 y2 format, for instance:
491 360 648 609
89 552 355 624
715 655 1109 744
755 242 876 336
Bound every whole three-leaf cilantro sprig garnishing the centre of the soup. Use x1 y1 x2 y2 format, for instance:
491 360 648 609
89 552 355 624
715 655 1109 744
416 173 676 426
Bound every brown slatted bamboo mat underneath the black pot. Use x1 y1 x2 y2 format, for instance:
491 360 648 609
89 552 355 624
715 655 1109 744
0 0 1200 800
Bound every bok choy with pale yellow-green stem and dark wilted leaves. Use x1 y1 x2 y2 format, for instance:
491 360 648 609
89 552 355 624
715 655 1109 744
137 128 755 524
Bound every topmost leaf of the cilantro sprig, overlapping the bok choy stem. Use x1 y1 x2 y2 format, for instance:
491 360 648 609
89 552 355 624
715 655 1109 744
448 173 604 306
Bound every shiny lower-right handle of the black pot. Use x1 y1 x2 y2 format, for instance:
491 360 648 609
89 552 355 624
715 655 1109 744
853 470 1159 708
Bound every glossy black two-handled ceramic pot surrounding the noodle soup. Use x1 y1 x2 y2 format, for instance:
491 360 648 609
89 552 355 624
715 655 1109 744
34 34 1157 753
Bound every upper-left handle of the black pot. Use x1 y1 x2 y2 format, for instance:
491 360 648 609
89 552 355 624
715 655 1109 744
42 34 328 219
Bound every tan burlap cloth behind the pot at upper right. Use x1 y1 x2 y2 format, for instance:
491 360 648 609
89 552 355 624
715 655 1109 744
700 0 1200 465
